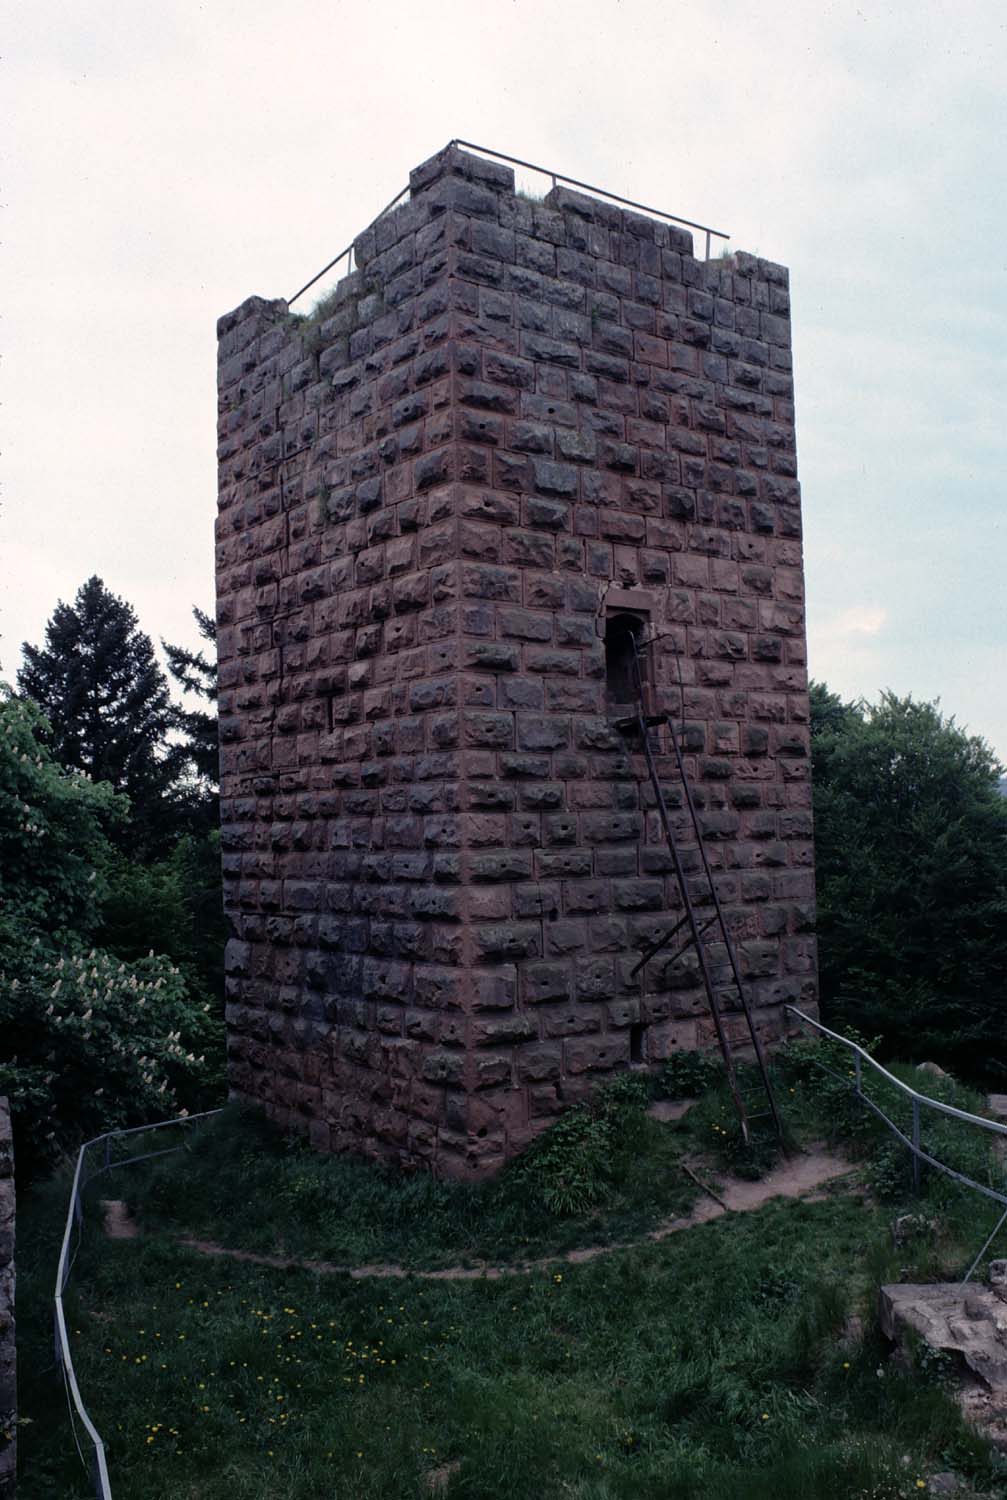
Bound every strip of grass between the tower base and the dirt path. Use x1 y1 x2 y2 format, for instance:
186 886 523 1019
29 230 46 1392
122 1074 696 1269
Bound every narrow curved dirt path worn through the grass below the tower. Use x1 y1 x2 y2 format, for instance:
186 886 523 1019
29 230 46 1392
151 1148 854 1281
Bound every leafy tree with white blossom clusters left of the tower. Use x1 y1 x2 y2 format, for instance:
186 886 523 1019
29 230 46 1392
0 684 222 1178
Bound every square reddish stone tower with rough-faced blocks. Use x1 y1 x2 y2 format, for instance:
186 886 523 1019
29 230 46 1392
218 147 816 1176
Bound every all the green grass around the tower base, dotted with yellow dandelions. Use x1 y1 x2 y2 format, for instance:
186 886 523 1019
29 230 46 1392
20 1055 1004 1500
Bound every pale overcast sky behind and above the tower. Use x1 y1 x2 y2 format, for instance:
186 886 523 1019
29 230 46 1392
0 0 1007 759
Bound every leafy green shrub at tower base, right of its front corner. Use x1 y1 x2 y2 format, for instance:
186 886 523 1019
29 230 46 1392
510 1073 648 1215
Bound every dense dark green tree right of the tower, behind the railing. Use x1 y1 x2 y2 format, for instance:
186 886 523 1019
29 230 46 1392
812 684 1007 1082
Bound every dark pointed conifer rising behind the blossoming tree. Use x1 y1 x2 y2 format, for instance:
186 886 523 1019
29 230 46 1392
18 578 183 854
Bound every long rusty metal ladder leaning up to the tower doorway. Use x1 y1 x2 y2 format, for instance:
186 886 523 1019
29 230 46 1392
615 635 783 1146
